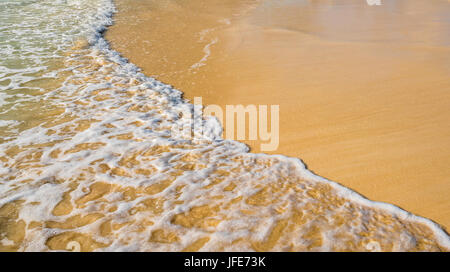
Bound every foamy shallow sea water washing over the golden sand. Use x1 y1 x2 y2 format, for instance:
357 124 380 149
0 0 450 251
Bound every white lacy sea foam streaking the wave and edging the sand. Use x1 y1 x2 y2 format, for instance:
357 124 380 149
0 0 450 251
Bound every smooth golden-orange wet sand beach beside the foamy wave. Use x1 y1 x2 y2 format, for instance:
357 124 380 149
106 0 450 229
